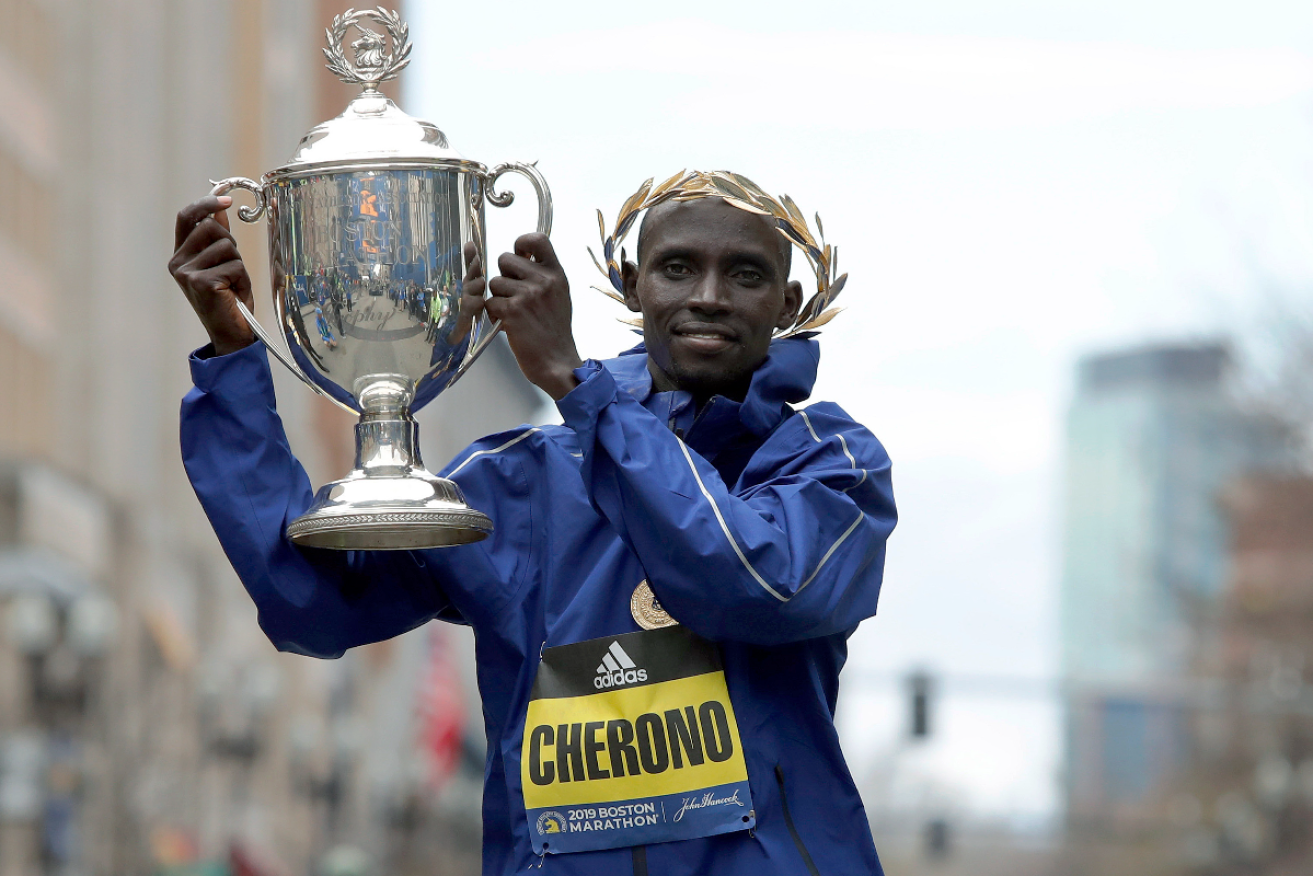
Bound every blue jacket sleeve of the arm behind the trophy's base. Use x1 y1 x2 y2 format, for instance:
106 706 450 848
181 344 485 657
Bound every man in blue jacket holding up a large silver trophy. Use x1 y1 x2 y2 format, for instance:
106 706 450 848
169 173 895 876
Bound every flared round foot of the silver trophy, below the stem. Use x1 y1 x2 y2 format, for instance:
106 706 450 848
288 469 492 550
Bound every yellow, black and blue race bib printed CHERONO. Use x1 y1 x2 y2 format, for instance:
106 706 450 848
520 626 756 855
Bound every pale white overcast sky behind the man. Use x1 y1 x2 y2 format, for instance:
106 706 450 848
403 0 1313 825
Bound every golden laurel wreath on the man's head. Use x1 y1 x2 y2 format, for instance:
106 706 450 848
588 171 848 338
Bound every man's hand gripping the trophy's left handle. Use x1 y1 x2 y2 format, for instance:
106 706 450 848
168 196 255 356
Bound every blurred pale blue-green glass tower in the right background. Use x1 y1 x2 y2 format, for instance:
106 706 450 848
1061 344 1295 827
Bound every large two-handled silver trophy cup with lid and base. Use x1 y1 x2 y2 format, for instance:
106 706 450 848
213 7 551 550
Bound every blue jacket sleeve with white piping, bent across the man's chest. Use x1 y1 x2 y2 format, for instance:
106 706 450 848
558 362 897 645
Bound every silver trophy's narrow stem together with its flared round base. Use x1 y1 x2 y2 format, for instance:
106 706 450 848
288 407 492 550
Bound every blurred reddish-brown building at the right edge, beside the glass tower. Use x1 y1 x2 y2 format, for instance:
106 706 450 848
1174 475 1313 876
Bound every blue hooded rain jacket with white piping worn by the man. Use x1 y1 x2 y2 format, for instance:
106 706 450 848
181 339 895 876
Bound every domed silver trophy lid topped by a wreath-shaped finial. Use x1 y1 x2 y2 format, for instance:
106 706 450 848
281 7 465 172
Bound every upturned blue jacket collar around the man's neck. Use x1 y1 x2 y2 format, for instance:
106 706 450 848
603 334 821 436
